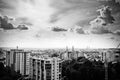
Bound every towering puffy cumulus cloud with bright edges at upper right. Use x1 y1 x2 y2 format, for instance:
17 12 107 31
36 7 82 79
90 6 115 34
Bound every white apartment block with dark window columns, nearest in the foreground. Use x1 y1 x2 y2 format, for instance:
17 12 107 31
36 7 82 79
30 57 62 80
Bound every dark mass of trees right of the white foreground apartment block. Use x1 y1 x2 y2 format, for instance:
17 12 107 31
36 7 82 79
62 57 120 80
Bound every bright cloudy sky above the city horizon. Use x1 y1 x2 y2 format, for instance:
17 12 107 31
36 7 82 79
0 0 120 48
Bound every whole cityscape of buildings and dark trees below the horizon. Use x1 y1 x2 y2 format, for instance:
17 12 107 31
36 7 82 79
0 47 120 80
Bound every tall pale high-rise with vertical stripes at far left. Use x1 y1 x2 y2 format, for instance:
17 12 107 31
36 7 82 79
6 49 30 75
